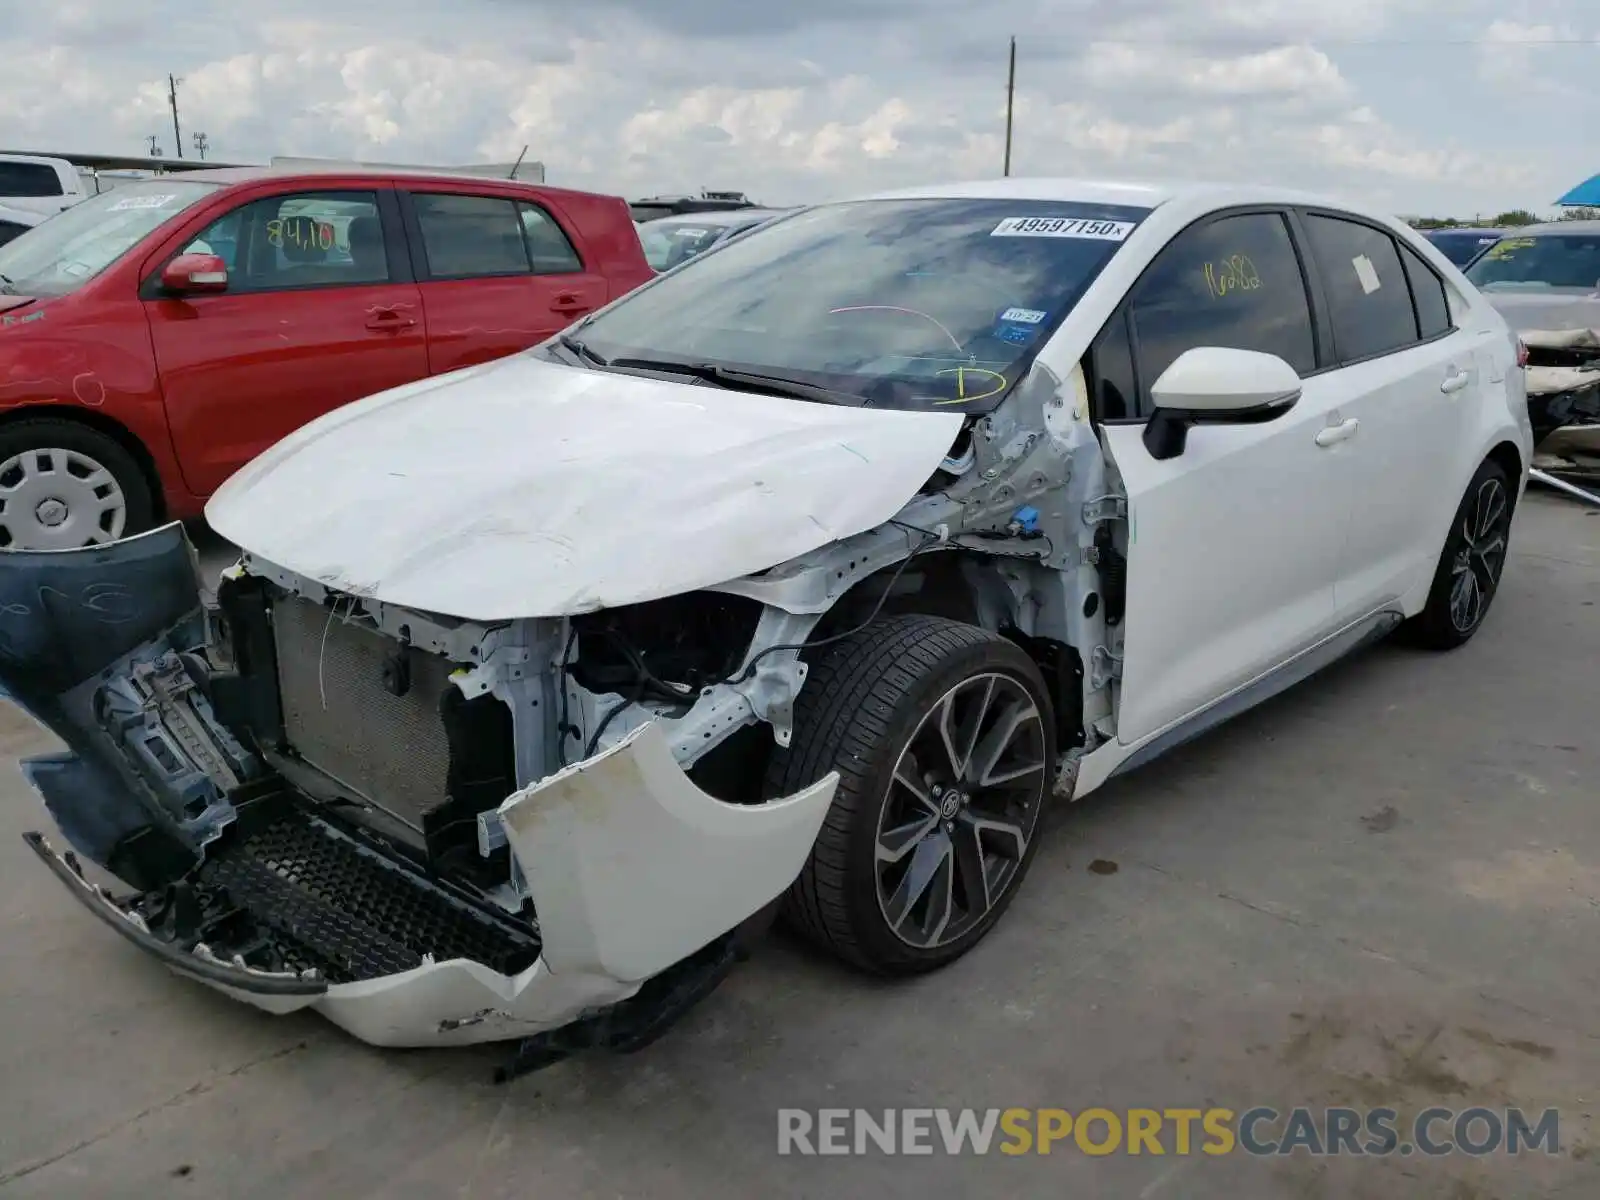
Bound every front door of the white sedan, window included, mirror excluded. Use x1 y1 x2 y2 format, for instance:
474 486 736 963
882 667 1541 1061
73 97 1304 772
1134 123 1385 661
1096 211 1350 744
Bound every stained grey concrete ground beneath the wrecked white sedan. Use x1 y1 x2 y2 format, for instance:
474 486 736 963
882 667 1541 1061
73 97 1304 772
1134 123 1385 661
0 494 1600 1200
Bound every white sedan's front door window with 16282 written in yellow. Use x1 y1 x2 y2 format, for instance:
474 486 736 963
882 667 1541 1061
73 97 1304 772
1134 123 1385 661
1130 213 1317 392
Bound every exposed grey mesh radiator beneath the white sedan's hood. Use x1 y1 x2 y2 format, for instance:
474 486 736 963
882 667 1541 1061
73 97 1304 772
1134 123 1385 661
272 595 451 829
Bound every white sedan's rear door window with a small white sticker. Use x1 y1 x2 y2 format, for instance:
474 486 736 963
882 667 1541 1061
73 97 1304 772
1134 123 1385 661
1306 214 1418 363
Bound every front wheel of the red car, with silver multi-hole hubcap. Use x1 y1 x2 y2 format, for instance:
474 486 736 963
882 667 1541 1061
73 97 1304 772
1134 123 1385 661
0 418 155 550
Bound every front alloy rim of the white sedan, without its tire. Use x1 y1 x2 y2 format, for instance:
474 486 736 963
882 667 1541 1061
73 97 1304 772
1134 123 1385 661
875 672 1050 949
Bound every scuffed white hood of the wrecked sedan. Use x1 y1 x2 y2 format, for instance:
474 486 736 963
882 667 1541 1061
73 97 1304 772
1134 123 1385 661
206 354 962 621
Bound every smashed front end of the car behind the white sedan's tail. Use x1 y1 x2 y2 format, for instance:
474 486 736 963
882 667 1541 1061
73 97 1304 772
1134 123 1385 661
1520 330 1600 502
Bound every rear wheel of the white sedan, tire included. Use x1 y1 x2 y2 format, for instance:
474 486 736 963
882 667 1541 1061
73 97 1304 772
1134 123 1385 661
1402 461 1517 650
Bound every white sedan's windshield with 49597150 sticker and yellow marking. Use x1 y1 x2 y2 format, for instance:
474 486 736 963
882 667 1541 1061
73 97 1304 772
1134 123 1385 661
571 200 1149 413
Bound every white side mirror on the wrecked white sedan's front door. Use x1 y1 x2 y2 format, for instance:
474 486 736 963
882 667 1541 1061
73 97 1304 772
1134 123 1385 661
1144 346 1301 459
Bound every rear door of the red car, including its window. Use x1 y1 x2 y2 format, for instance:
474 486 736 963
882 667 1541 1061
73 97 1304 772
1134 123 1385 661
402 187 608 374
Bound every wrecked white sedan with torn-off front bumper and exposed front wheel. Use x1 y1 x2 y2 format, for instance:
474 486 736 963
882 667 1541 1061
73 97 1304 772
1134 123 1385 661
0 179 1531 1058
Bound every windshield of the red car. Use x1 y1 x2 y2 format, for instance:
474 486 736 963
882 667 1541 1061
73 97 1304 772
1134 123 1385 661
0 179 219 296
